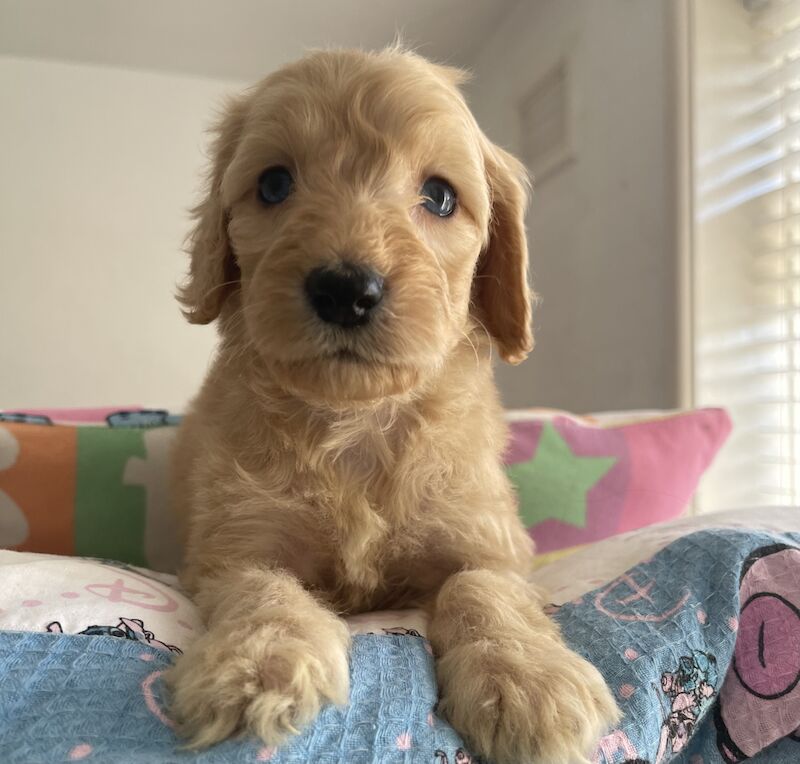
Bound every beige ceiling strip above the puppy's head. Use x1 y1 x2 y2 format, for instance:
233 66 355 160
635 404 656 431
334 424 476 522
0 0 528 80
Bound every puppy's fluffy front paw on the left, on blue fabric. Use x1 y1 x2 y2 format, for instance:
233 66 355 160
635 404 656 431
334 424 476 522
165 624 349 748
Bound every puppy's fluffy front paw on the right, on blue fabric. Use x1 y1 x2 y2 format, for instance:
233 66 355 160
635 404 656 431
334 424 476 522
438 640 619 764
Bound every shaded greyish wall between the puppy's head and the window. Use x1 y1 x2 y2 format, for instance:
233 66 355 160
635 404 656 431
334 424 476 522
471 0 678 411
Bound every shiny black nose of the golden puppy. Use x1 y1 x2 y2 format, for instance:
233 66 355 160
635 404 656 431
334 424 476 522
306 263 383 327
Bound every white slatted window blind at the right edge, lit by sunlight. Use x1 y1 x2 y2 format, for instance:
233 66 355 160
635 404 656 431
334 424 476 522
694 0 800 511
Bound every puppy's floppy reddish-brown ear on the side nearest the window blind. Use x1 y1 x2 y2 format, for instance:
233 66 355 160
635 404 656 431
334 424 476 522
473 139 533 364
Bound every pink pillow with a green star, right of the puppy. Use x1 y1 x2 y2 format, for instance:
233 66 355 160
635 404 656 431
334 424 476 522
506 409 731 553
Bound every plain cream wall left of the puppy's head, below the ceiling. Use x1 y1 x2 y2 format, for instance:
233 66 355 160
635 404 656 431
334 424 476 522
0 57 238 408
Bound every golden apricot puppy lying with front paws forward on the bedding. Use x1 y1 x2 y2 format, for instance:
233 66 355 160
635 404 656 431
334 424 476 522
168 48 618 764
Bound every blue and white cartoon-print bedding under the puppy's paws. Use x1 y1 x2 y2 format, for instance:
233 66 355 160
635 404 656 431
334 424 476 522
0 509 800 764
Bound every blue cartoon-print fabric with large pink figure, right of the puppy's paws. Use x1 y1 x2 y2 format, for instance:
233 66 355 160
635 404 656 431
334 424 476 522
555 532 800 764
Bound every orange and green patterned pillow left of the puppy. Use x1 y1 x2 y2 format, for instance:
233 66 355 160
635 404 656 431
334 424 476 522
0 409 180 571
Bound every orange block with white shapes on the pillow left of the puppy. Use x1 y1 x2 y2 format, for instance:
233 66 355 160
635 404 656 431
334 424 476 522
0 423 77 554
